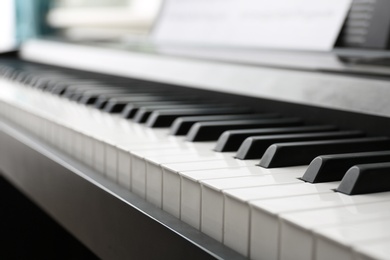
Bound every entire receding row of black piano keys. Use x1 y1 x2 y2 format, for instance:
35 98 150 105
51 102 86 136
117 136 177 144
0 61 390 194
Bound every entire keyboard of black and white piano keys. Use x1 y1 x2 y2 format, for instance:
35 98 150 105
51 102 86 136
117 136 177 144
0 57 390 260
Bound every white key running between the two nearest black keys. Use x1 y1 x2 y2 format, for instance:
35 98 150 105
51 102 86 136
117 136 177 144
223 182 338 256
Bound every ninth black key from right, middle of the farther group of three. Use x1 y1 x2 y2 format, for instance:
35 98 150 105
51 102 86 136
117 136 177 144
133 102 222 123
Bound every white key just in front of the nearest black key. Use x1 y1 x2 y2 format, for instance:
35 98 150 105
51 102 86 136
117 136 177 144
249 192 390 260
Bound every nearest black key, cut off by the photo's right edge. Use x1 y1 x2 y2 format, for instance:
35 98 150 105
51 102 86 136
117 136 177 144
337 162 390 195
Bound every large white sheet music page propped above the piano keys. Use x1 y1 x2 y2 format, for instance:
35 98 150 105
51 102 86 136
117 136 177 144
154 0 351 51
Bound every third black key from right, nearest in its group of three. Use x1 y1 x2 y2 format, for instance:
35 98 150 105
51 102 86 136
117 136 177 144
259 137 390 168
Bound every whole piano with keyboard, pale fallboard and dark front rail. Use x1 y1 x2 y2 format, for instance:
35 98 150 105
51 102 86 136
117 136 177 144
0 1 390 260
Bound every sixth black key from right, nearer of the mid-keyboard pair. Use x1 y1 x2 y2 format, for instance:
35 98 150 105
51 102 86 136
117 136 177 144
186 118 303 142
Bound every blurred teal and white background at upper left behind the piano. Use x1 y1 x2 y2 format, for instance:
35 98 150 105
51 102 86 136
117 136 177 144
0 0 161 52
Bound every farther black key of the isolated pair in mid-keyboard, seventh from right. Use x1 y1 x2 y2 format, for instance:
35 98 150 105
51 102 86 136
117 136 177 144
170 113 280 136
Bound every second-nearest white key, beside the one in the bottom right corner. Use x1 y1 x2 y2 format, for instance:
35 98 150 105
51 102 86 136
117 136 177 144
314 219 390 260
